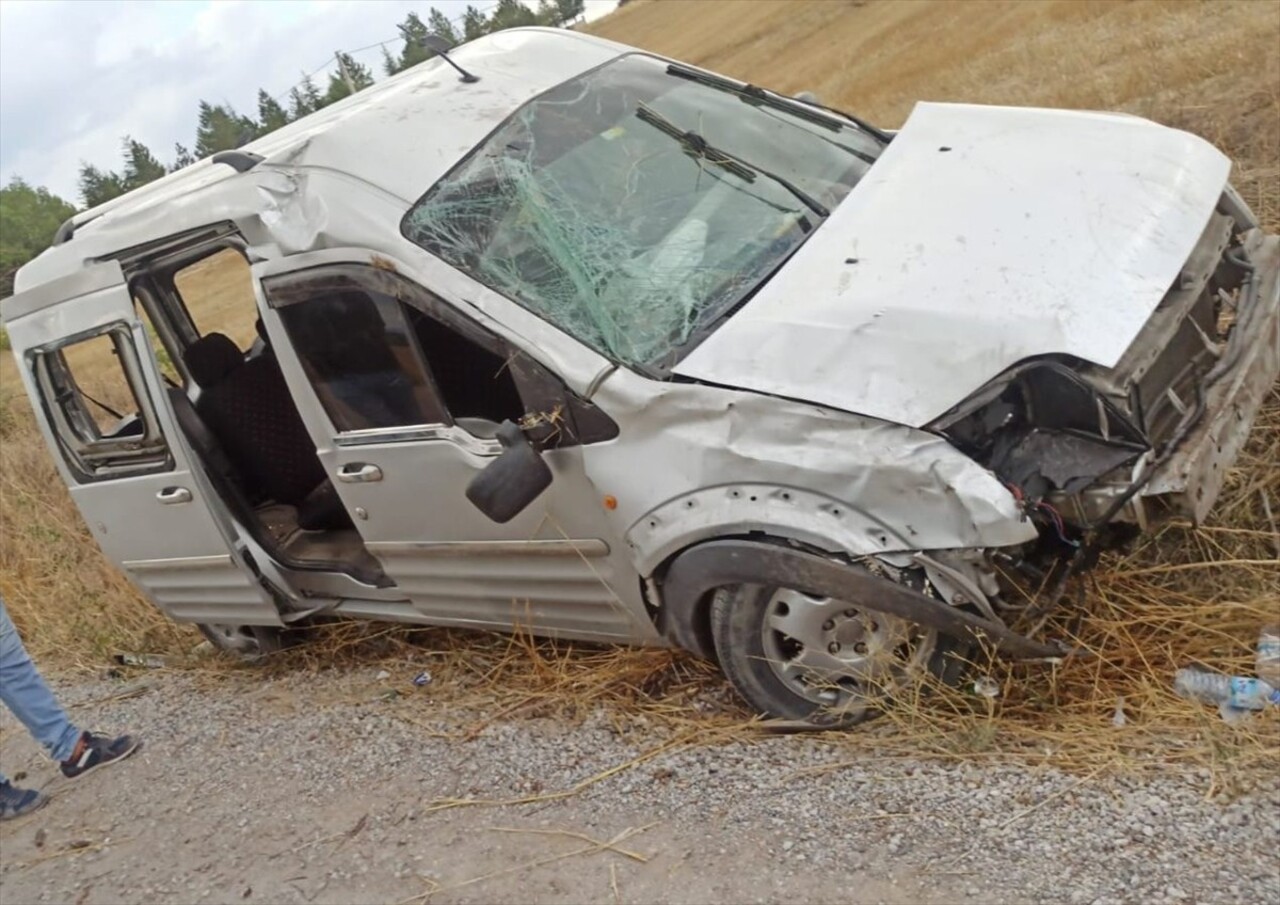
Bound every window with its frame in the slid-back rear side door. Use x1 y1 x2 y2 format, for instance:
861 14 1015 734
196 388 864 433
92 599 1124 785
29 324 172 483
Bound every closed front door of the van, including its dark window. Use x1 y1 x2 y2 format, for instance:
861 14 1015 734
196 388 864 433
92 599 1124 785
255 250 654 641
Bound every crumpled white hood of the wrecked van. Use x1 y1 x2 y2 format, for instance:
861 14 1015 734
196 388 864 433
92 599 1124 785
676 104 1230 426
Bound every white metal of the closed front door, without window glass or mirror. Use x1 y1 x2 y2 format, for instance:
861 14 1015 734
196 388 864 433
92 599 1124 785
253 248 658 643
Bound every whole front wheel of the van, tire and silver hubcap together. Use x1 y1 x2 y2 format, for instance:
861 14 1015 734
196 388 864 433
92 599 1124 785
710 579 970 727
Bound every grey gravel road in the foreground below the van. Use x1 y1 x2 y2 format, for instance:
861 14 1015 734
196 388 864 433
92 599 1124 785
0 669 1280 905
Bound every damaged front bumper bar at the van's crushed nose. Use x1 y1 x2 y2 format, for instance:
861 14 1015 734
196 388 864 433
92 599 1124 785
1129 232 1280 525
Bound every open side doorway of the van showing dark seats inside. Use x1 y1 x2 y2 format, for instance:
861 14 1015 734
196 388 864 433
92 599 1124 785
131 248 390 586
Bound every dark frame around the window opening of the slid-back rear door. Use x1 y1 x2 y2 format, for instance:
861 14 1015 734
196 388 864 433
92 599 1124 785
26 320 174 484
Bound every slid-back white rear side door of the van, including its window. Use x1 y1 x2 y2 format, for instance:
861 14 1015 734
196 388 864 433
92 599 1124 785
4 261 282 625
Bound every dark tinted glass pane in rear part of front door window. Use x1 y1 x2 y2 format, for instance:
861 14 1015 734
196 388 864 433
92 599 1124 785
279 286 445 431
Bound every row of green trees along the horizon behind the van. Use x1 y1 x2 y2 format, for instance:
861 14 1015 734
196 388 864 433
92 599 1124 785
0 0 584 297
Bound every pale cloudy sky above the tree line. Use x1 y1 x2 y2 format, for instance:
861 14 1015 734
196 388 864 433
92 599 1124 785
0 0 616 204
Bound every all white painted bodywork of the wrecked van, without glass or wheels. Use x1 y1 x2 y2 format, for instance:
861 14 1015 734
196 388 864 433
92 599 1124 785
0 29 1280 660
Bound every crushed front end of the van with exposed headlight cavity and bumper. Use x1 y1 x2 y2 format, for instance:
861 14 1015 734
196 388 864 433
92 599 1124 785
931 188 1280 559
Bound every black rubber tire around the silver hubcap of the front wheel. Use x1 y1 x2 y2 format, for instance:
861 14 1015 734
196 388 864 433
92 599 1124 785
710 588 973 728
